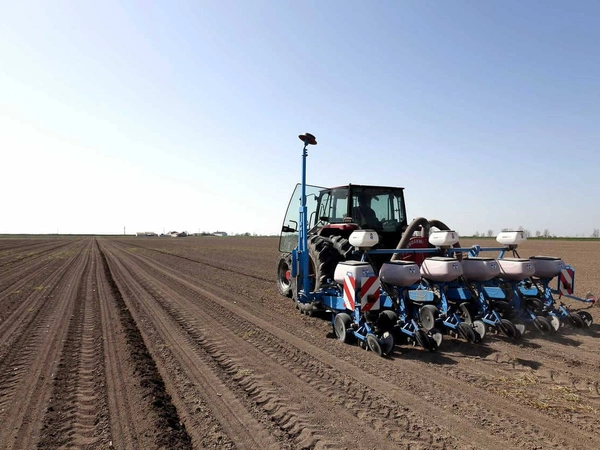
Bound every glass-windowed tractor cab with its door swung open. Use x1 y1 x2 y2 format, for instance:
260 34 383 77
279 184 407 252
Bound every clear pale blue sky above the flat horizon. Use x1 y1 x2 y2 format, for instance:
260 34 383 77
0 0 600 236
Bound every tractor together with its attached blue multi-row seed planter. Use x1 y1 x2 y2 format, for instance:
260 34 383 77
277 133 596 355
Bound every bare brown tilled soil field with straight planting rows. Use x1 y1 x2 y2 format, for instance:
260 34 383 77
0 236 600 450
